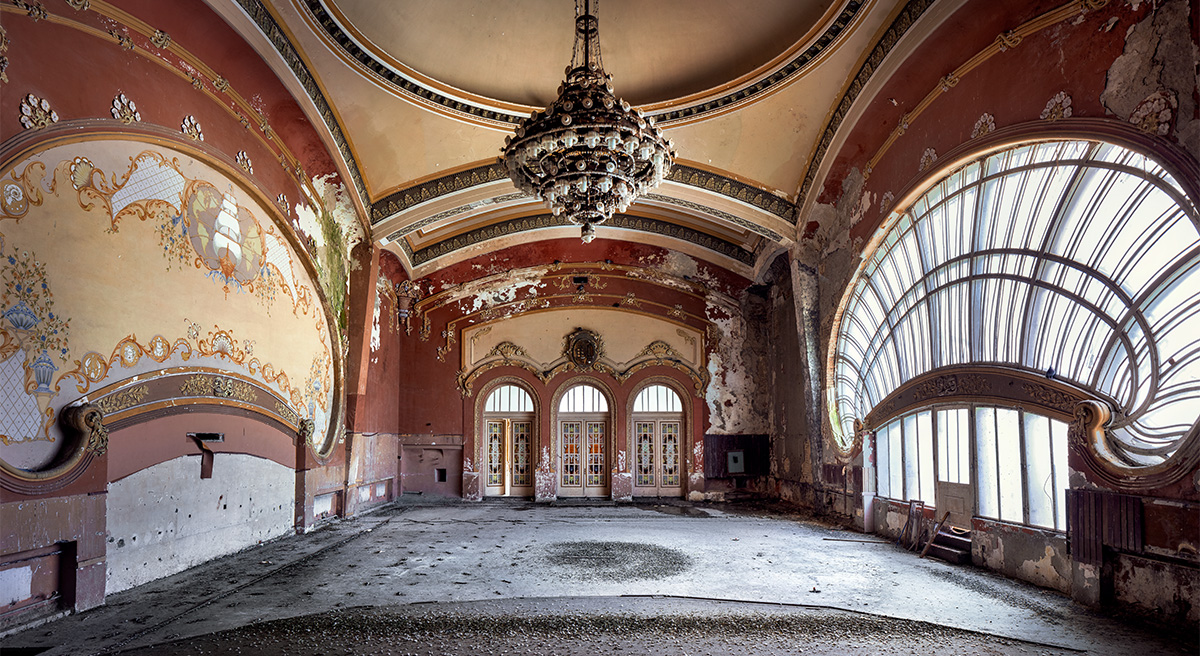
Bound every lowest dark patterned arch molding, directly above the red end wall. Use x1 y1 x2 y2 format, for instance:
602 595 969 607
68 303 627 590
408 215 755 266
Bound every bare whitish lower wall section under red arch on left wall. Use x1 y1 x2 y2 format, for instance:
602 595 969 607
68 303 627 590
106 453 295 594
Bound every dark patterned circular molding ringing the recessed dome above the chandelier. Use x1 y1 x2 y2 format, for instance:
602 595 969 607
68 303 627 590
298 0 866 128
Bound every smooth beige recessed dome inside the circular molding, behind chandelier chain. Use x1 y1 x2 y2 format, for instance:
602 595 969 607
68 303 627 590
328 0 833 108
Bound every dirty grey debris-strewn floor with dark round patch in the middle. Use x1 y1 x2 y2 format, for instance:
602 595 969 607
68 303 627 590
0 498 1196 656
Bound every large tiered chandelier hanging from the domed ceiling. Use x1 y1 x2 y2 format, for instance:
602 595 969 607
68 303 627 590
502 0 676 242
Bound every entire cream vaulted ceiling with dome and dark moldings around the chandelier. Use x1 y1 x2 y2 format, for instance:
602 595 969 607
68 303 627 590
253 0 898 275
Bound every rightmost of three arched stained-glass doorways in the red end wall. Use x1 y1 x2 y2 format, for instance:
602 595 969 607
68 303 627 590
631 385 683 496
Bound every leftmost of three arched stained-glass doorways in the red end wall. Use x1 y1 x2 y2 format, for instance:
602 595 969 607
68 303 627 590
484 385 535 496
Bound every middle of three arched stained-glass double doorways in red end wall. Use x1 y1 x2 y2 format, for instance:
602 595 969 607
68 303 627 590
558 384 610 496
